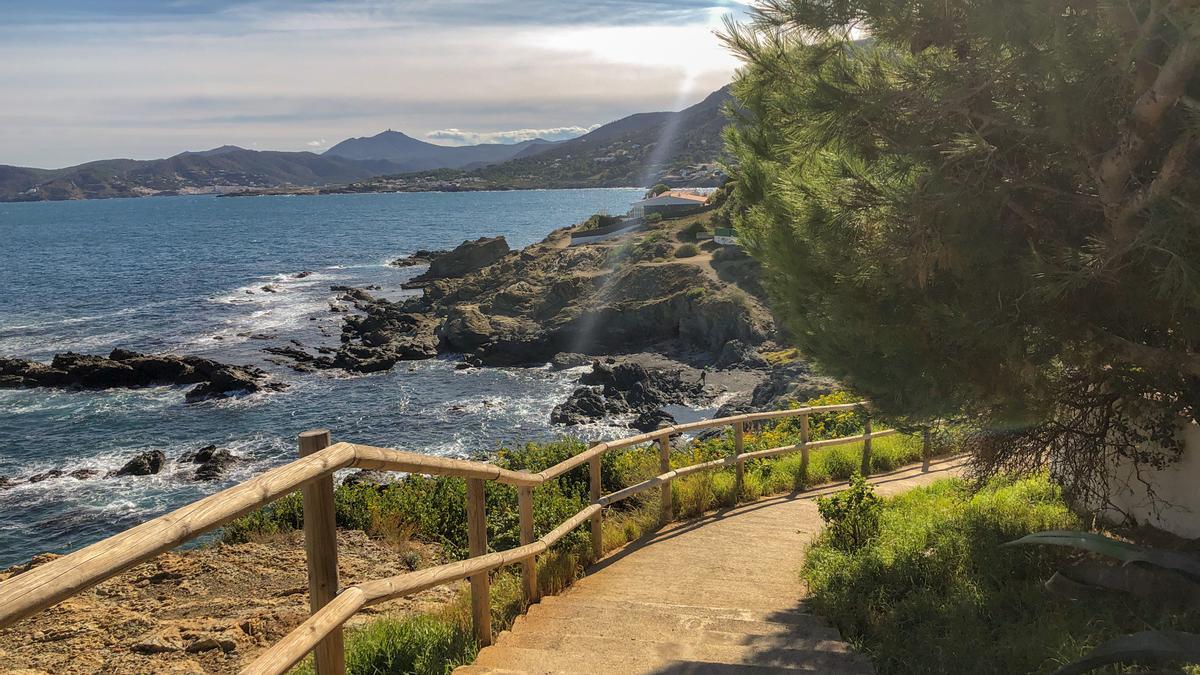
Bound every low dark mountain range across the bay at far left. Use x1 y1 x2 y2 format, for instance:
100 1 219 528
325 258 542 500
0 145 408 202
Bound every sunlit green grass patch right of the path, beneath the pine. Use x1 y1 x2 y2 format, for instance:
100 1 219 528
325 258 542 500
803 478 1200 673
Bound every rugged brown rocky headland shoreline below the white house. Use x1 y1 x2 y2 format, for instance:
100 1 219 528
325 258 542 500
255 210 833 420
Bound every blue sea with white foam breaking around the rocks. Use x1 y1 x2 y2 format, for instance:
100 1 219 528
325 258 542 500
0 189 642 568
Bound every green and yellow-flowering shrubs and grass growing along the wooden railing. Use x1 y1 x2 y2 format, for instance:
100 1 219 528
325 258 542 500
223 393 945 674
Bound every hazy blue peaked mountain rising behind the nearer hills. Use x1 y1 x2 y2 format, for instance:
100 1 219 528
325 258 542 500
324 129 557 171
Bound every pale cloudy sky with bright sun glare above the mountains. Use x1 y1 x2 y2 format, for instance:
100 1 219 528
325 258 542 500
0 0 745 168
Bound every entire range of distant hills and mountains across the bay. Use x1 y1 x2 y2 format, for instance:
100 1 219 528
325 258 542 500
0 86 731 202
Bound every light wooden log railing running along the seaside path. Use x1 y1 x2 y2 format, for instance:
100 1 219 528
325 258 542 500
0 404 930 675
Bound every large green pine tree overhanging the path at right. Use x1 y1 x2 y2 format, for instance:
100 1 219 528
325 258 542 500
726 0 1200 502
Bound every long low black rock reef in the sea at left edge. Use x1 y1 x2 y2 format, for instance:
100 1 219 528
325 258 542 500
0 350 283 401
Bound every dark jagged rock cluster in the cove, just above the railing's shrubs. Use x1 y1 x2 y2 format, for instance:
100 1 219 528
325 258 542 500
550 360 712 422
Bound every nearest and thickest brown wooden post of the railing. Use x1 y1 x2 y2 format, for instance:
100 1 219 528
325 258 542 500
300 429 346 675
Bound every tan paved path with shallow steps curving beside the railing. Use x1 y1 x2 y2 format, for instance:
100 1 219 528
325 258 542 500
455 459 961 675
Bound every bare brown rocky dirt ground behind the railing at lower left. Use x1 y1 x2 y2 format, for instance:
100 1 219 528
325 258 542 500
0 531 458 675
